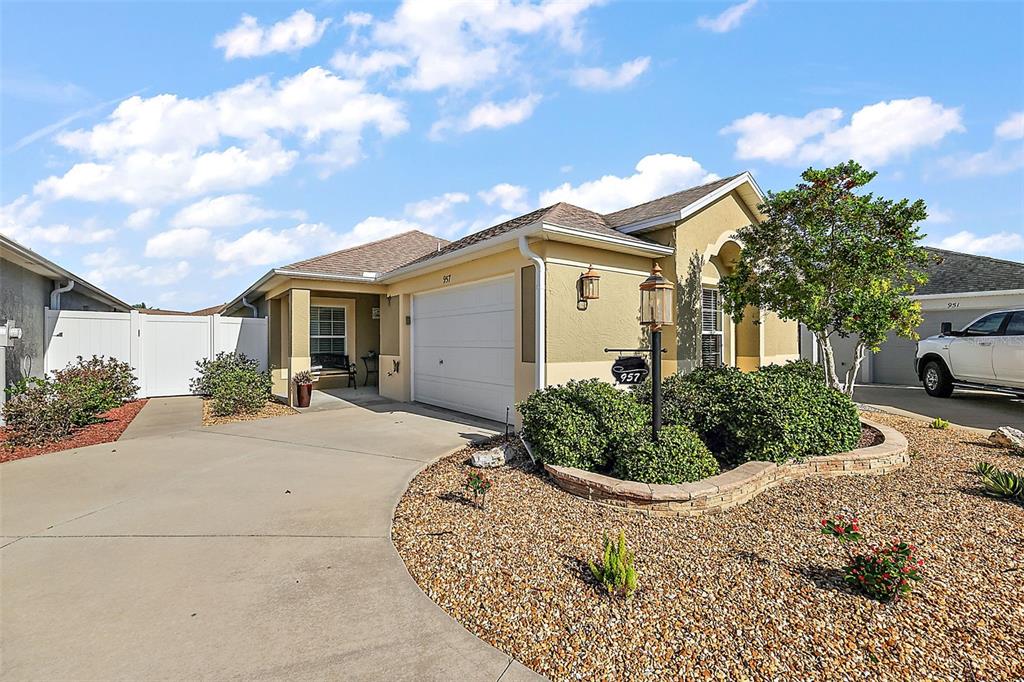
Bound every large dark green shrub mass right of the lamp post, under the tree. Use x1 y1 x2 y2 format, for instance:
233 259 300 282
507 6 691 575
636 363 860 467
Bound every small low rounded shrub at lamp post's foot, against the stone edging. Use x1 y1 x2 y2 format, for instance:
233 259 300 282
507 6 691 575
614 426 719 483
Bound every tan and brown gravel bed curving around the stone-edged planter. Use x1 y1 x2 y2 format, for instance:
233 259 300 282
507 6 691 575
392 414 1024 681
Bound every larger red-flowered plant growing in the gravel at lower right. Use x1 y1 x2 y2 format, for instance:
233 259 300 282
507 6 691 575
821 516 925 601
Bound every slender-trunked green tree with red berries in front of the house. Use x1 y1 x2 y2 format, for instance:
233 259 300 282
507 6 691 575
721 161 931 395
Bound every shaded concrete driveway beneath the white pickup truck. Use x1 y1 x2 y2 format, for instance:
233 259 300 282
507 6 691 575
853 384 1024 429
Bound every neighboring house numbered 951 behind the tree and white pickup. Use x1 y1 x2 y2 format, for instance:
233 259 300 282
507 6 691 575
800 247 1024 386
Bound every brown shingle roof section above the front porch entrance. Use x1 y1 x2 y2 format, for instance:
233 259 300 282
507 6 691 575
281 229 449 276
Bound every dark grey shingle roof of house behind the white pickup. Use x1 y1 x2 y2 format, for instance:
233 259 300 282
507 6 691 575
914 247 1024 295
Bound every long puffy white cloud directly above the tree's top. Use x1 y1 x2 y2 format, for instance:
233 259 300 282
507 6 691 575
721 97 965 166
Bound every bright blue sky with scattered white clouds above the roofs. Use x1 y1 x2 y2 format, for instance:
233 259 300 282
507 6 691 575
0 0 1024 310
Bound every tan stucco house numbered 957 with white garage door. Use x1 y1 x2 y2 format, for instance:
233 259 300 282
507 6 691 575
224 173 799 420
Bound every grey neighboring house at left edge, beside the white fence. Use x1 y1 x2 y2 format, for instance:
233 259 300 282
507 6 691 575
0 235 130 411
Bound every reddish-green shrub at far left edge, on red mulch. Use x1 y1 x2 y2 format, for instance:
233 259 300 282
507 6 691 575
3 377 75 446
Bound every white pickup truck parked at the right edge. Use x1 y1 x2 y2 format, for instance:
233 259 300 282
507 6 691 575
914 308 1024 397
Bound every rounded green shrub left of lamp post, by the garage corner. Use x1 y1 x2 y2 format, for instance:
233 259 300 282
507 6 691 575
517 379 649 471
